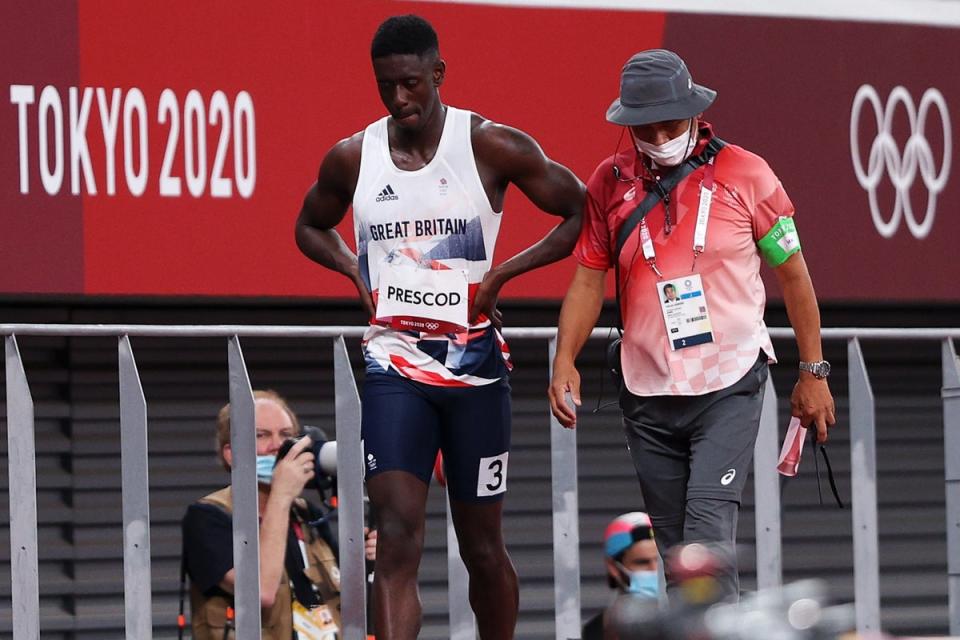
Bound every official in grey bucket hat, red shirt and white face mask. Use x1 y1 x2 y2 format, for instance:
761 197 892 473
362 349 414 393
548 42 836 608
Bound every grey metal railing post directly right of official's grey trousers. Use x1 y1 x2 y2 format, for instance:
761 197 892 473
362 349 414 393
753 376 783 589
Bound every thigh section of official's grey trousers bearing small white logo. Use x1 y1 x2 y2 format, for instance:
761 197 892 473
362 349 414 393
687 359 768 503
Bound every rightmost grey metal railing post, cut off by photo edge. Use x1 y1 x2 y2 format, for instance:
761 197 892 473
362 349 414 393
942 338 960 636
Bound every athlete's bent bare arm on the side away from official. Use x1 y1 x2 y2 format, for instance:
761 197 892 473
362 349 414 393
296 134 375 317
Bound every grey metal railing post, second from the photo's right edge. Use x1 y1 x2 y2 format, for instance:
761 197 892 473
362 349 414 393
847 338 880 634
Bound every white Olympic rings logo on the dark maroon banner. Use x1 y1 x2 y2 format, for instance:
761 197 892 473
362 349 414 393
850 84 953 240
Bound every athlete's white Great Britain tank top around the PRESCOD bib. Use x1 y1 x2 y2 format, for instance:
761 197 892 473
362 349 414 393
353 106 509 386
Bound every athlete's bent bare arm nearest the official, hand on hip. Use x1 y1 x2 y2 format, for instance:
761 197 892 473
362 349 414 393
470 121 585 322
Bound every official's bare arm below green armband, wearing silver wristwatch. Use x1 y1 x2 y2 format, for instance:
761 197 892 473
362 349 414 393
773 251 837 442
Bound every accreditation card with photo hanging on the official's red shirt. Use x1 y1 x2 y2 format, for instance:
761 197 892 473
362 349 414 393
656 273 713 351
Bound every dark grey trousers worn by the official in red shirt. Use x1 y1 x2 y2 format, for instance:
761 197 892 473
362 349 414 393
620 353 769 600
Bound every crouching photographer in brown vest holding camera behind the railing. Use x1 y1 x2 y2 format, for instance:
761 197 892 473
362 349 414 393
183 391 376 640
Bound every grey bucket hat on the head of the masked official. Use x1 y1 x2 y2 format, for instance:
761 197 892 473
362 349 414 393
607 49 717 126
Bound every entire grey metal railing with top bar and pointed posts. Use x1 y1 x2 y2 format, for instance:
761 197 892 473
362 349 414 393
0 324 960 640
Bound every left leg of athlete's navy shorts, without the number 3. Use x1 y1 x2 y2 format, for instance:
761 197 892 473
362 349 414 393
360 374 440 484
